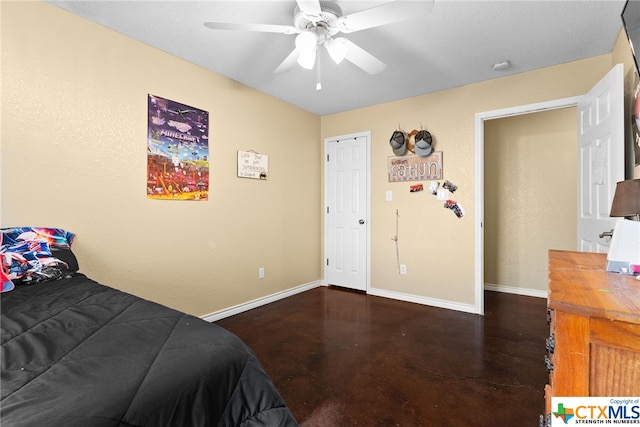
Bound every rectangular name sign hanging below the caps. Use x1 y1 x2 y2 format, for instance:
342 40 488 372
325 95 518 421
388 151 442 182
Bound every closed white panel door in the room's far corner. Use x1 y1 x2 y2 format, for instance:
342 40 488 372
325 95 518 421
325 132 370 291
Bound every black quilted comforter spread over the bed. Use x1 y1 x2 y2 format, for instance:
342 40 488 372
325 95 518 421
0 274 297 427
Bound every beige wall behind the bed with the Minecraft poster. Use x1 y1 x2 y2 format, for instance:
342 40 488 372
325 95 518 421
0 2 322 315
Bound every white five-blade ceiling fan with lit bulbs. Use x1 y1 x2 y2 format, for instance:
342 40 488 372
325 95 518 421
204 0 433 80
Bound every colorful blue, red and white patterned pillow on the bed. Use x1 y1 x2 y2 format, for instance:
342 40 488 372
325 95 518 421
0 227 78 292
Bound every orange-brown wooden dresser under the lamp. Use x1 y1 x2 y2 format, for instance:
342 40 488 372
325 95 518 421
541 250 640 425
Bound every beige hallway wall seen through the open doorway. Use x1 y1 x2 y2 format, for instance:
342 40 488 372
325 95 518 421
484 107 578 292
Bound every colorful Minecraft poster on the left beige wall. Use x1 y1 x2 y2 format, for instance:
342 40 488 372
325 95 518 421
147 95 209 200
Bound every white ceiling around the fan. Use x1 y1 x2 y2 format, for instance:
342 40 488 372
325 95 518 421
49 0 626 116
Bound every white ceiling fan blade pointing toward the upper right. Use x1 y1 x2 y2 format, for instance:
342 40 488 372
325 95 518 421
336 0 433 33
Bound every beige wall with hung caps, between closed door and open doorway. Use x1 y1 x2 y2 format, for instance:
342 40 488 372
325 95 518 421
322 55 612 306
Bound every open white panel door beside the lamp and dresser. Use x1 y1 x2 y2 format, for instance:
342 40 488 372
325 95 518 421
578 64 624 253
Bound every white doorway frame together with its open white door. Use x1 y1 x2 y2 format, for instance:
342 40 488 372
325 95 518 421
475 64 625 314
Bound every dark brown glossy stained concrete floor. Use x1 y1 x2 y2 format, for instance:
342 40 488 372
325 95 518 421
216 287 549 427
